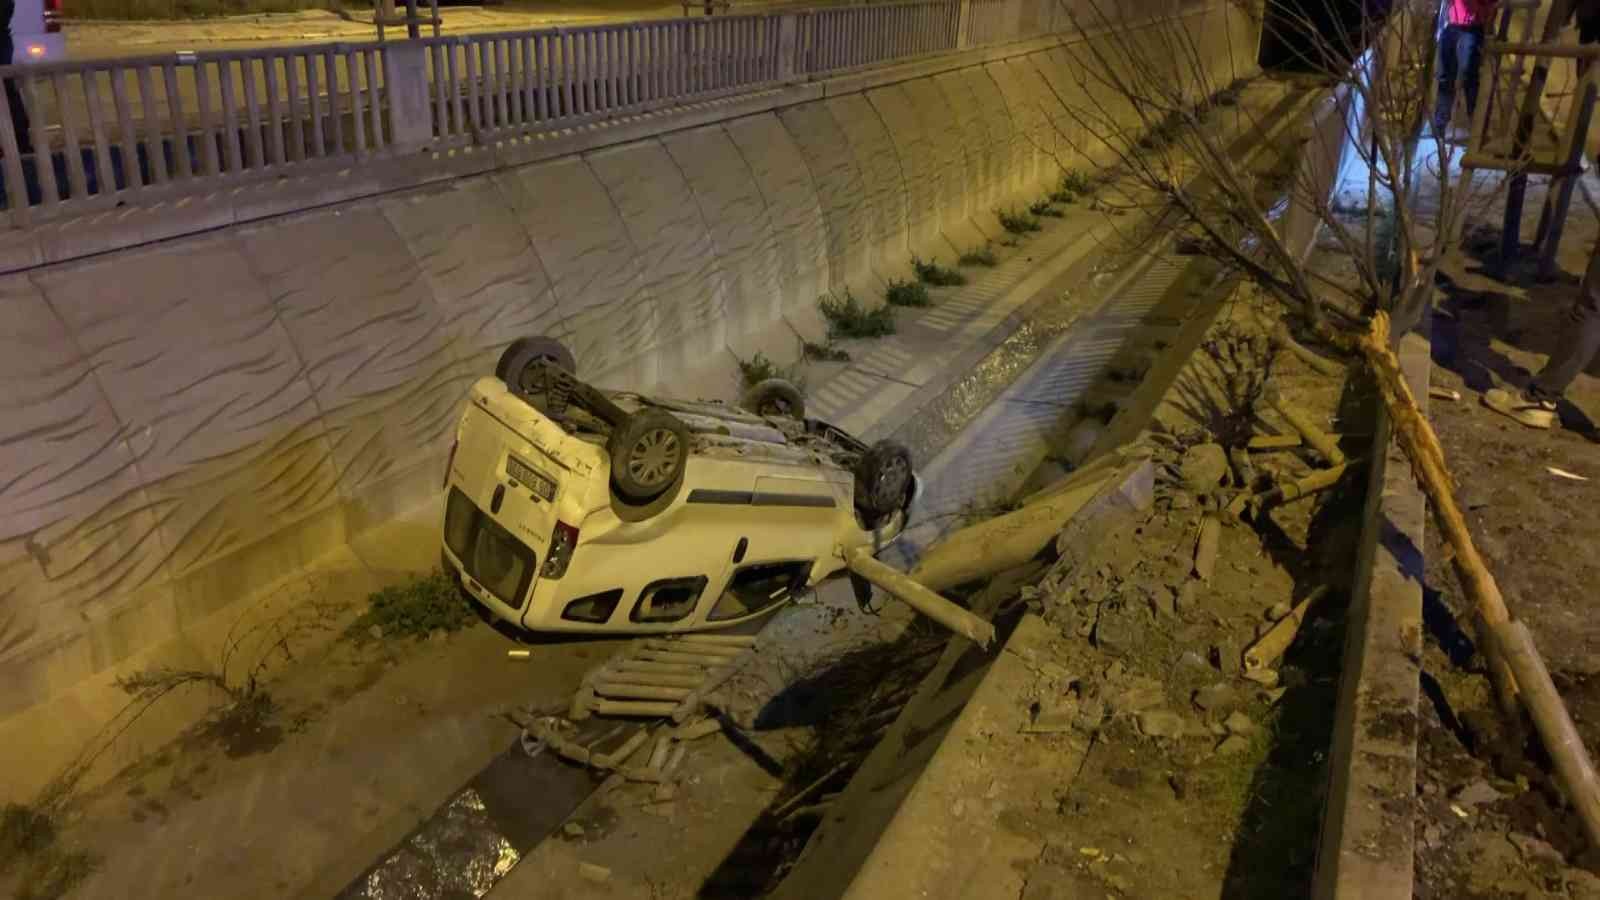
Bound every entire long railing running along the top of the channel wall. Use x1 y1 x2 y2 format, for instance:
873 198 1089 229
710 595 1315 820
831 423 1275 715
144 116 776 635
0 0 1100 226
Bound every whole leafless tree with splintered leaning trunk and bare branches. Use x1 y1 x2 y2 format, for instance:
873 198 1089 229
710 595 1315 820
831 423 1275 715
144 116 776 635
1058 0 1600 844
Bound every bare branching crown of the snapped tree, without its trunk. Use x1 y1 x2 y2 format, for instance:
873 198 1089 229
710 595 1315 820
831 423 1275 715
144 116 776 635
1067 0 1488 341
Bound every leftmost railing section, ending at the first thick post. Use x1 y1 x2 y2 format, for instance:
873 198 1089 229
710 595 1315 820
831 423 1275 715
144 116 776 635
0 43 389 221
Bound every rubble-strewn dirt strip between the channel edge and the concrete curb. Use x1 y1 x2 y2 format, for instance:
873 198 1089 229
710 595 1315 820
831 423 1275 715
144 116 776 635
953 281 1373 900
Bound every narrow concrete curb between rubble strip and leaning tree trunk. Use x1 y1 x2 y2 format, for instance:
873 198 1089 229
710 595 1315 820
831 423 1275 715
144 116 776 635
1312 318 1432 900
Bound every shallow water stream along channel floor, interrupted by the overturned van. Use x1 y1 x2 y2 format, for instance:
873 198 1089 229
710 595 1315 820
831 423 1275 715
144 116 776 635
328 227 1227 900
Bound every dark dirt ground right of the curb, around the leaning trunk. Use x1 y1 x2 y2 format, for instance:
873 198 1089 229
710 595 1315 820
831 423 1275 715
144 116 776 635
1416 176 1600 898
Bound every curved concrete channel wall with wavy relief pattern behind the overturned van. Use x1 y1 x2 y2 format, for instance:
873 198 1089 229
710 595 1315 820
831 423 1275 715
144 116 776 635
0 6 1256 799
